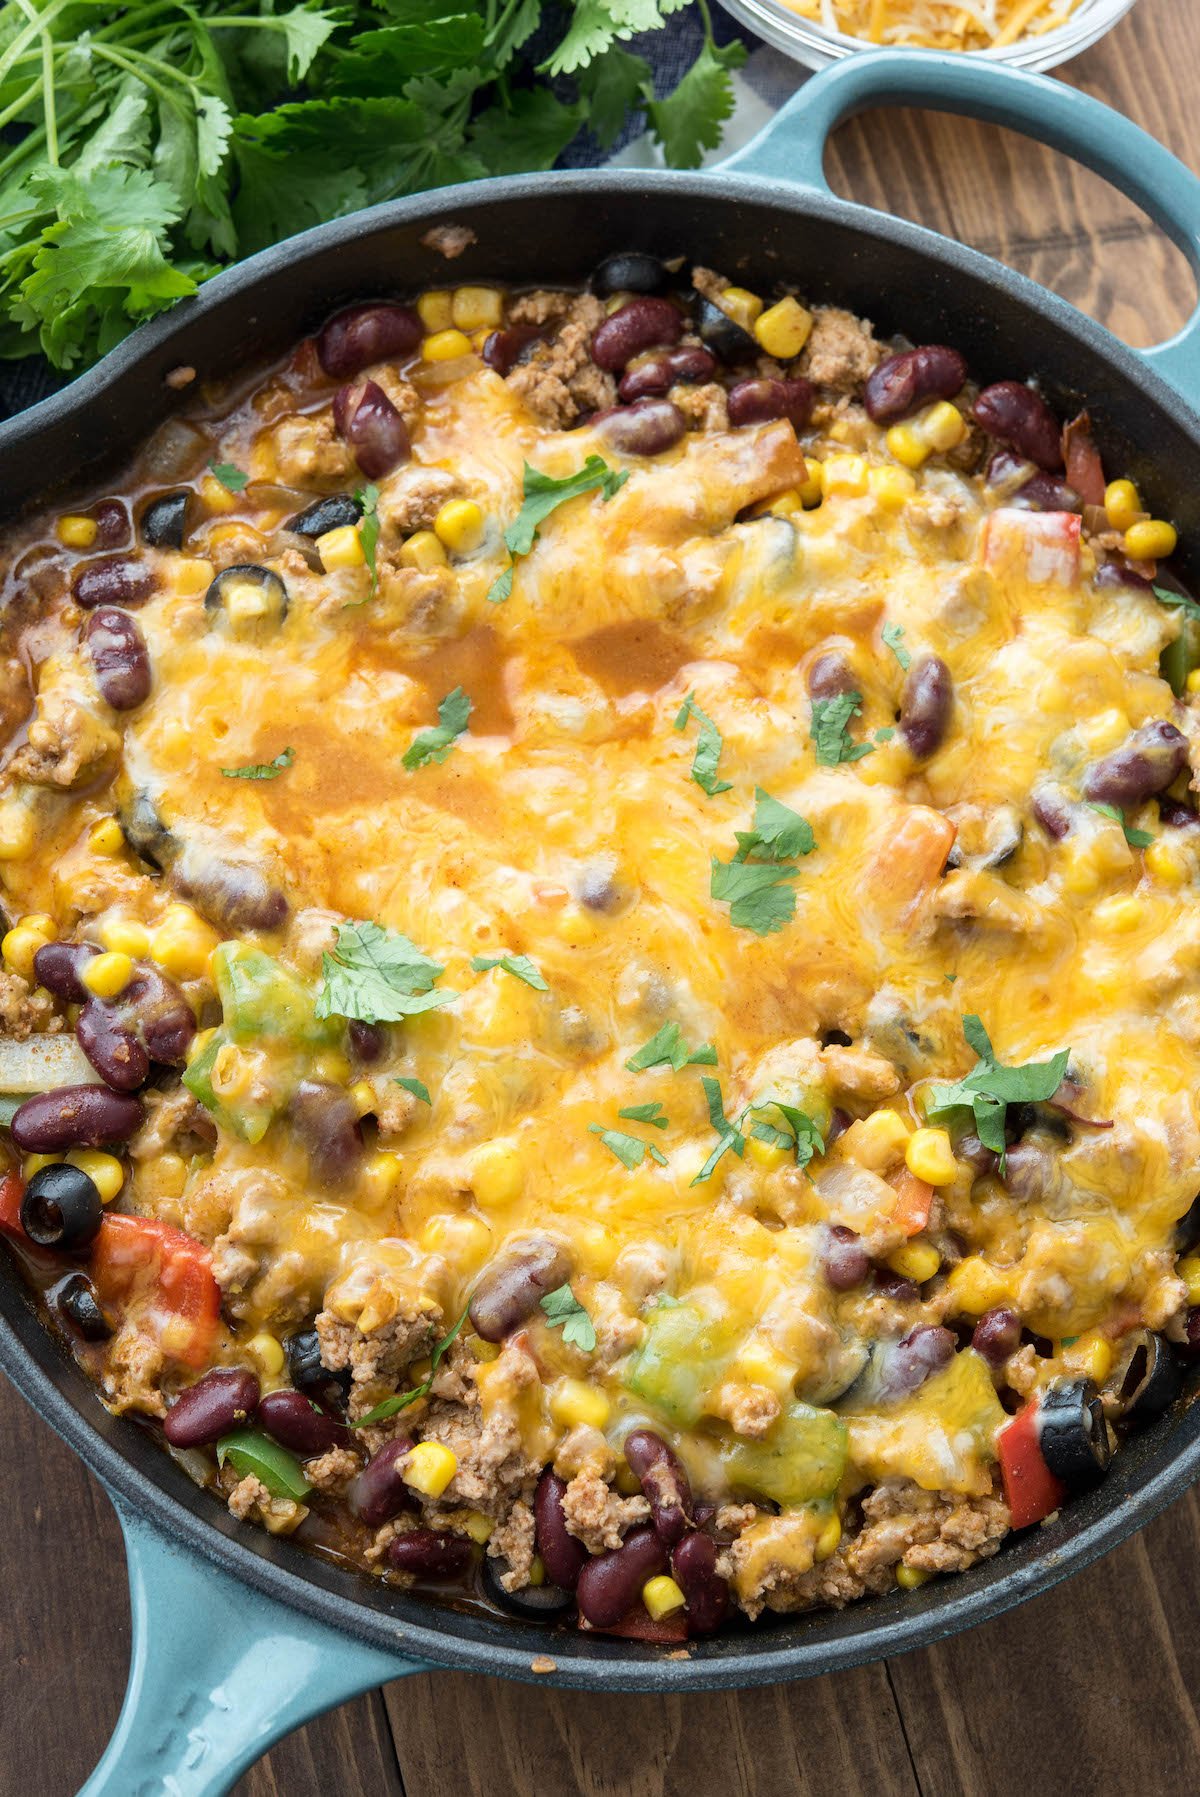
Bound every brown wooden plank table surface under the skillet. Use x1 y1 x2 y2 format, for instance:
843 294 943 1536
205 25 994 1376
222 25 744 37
0 0 1200 1797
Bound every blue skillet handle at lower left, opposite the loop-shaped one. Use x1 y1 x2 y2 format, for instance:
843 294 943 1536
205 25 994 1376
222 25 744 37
79 1500 426 1797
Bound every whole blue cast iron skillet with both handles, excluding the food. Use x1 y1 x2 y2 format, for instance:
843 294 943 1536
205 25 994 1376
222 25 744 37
0 52 1200 1797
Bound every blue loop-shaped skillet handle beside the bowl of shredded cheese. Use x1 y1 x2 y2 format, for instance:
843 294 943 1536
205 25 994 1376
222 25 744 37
722 50 1200 410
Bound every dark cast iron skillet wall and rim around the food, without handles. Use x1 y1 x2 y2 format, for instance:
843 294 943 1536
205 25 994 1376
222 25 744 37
0 171 1200 1691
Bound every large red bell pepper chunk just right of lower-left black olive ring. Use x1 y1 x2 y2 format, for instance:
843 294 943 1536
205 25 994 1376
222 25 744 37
88 1213 221 1368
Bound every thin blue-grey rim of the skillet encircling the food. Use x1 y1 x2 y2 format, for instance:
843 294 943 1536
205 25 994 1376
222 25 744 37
0 169 1200 1693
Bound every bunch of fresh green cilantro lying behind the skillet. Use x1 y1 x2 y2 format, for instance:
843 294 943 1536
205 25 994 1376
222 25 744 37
0 0 744 368
